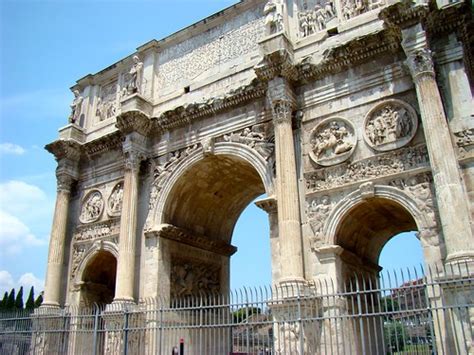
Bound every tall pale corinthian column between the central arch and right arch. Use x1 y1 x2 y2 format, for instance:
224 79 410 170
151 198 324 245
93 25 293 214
269 77 304 282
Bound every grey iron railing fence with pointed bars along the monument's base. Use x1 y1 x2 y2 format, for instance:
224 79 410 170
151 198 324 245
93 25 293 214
0 264 474 355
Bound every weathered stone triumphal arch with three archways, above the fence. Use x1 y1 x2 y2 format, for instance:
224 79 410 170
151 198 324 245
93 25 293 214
44 0 474 350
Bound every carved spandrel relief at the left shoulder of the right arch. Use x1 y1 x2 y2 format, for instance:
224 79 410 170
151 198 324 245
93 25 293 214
306 196 332 250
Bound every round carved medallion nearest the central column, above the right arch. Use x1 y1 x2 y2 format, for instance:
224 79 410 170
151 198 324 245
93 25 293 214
309 117 357 166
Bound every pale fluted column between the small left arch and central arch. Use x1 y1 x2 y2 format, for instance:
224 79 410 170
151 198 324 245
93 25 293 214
114 153 141 302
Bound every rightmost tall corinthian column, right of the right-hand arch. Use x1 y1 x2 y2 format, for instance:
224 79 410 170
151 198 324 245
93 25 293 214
402 25 474 262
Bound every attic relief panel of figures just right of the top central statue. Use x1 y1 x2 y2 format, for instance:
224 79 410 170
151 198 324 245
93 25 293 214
298 0 336 37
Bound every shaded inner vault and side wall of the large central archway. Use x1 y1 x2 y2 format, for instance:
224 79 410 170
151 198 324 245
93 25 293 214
162 155 270 298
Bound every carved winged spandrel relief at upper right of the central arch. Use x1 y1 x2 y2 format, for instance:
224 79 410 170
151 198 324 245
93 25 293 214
224 126 275 160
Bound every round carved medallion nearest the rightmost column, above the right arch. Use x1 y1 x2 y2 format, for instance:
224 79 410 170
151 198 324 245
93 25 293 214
364 99 418 151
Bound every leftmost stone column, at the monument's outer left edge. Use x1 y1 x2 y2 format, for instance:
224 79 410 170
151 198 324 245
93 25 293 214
43 175 73 307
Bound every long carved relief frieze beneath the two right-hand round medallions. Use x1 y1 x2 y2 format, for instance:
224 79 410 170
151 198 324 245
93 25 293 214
305 145 429 191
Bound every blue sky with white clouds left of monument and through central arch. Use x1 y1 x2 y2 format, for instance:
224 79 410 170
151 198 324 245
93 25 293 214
0 0 422 293
